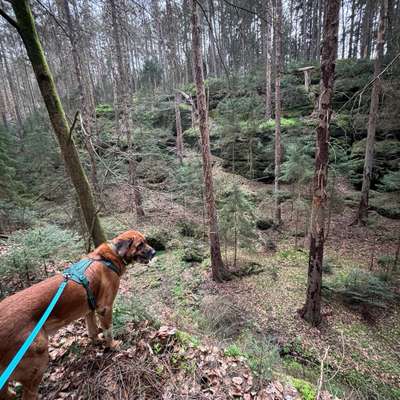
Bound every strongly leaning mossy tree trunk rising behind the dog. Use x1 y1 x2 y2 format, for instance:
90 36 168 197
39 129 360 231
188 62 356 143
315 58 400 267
12 0 107 246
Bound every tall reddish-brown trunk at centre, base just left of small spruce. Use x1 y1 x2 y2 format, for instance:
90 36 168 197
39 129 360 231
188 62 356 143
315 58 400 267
191 0 229 282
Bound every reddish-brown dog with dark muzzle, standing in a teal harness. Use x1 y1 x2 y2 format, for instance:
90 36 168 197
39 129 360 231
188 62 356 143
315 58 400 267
0 231 155 400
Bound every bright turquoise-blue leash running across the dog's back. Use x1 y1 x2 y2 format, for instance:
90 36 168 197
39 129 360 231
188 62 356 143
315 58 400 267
0 278 68 390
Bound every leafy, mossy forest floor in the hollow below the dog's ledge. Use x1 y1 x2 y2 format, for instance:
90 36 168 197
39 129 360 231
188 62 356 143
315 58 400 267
76 162 400 399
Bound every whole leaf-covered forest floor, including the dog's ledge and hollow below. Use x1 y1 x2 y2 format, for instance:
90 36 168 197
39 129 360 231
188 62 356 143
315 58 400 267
3 165 400 400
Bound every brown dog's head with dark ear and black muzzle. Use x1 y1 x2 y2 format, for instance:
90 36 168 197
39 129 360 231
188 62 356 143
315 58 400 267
111 231 156 264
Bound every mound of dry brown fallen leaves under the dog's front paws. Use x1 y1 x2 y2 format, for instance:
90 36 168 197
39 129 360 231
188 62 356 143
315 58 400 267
36 321 328 400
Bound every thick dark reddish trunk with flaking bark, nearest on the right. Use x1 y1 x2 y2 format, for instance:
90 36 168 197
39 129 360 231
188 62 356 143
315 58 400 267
300 0 340 326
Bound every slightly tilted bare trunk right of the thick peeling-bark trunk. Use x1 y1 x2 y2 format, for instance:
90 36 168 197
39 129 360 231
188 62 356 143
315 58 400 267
353 0 388 225
